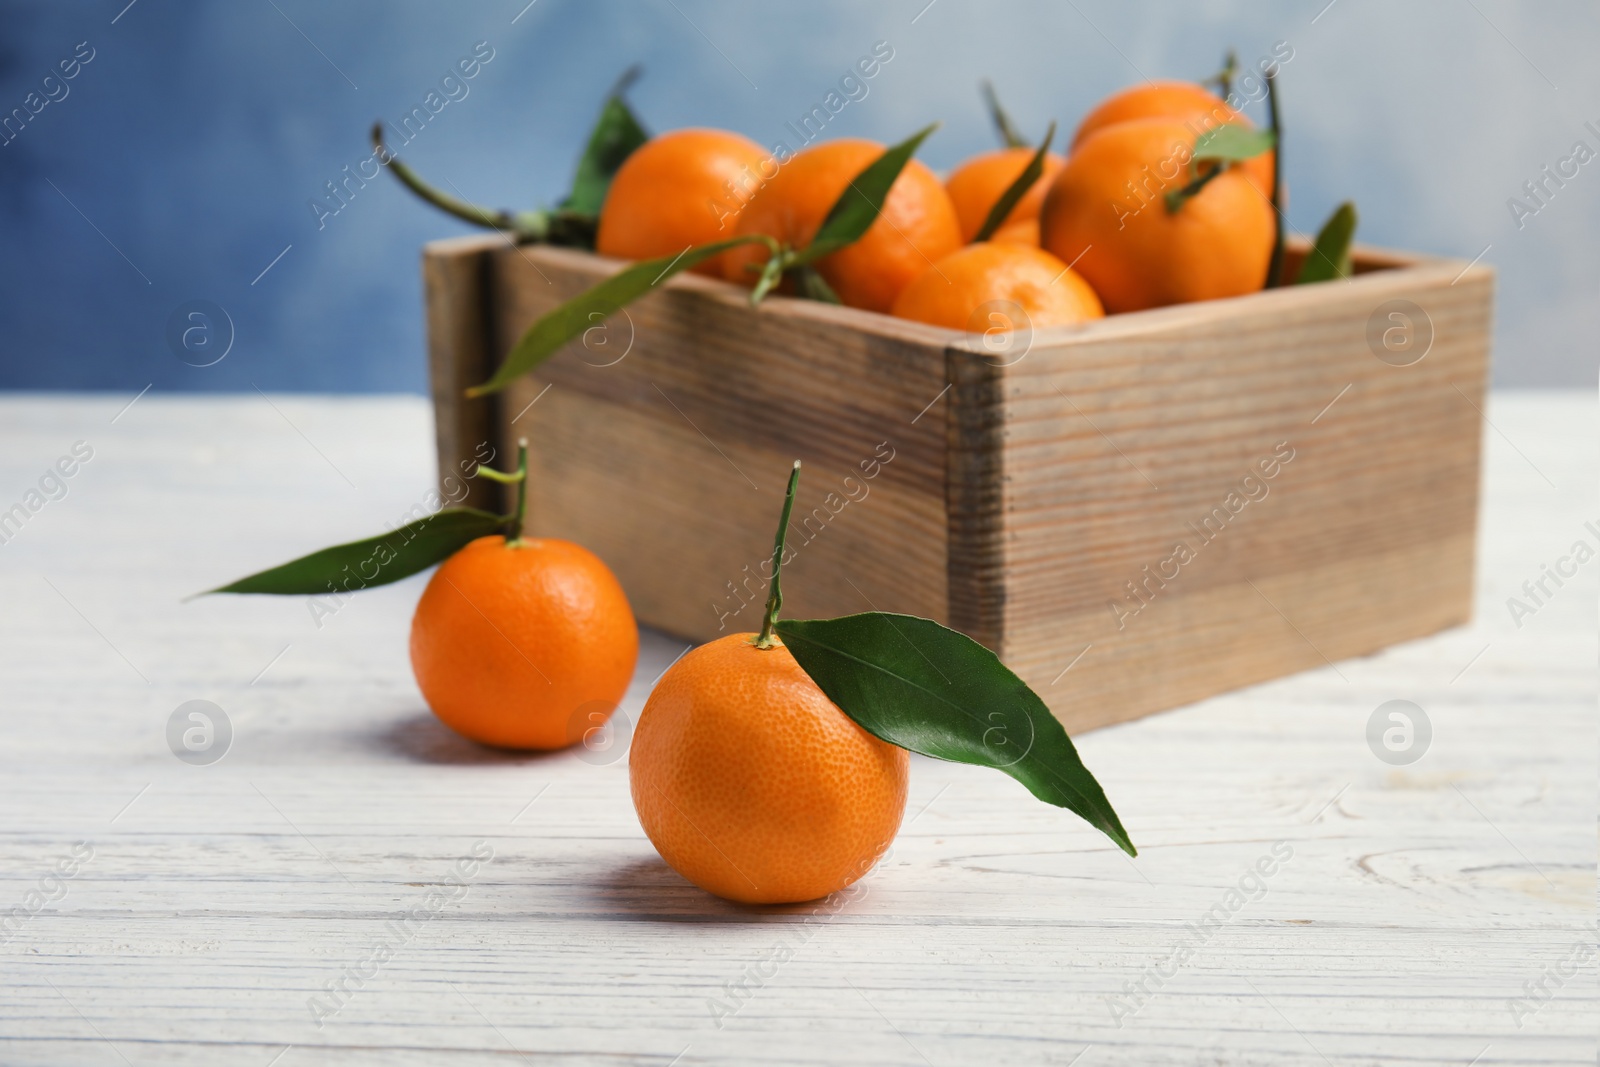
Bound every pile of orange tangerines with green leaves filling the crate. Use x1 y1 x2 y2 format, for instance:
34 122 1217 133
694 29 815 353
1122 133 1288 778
378 54 1355 383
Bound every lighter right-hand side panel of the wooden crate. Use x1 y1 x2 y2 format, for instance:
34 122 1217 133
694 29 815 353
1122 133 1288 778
1003 269 1491 721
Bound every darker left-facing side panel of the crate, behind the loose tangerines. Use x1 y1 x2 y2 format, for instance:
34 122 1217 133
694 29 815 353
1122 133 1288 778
498 250 947 640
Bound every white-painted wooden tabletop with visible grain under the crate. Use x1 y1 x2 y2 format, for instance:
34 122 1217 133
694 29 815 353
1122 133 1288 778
0 394 1600 1067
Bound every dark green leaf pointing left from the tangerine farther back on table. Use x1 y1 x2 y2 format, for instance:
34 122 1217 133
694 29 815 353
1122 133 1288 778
200 507 507 595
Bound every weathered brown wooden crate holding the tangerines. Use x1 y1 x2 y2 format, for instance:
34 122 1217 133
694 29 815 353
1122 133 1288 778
422 238 1493 731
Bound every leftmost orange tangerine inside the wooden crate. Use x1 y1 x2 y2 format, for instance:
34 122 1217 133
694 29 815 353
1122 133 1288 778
595 130 773 277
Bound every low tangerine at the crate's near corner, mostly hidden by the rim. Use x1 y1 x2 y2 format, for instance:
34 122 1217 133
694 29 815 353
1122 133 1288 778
893 242 1106 333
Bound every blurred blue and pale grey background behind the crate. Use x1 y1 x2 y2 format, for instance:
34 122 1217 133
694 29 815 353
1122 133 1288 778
0 0 1600 394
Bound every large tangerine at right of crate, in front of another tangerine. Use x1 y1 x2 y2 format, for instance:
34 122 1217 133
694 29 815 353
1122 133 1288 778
1038 118 1274 314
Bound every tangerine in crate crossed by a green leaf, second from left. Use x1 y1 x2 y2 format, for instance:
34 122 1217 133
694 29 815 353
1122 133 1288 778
723 138 962 312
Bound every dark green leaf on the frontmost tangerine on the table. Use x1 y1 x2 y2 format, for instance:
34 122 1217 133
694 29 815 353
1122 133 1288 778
778 611 1138 856
